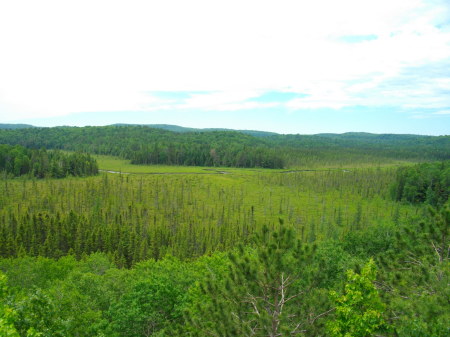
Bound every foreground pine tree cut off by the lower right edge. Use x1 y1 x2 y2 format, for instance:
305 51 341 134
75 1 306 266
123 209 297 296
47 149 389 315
380 202 450 337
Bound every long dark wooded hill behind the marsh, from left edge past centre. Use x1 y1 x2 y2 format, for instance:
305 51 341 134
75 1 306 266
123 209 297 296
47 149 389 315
0 126 285 168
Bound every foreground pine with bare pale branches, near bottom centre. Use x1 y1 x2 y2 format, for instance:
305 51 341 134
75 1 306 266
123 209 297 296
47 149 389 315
189 227 321 337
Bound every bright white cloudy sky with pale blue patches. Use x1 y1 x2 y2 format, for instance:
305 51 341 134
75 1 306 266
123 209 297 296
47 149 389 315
0 0 450 135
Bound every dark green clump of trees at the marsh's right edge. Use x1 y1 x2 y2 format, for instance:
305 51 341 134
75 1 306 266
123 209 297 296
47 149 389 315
392 161 450 207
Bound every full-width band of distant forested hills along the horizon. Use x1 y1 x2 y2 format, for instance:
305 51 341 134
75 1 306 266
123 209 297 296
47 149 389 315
0 126 450 168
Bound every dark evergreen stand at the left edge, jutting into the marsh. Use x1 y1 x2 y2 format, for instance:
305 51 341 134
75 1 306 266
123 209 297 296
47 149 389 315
0 144 98 178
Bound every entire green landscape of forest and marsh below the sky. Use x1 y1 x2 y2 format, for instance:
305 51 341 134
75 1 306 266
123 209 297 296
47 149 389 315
0 125 450 337
